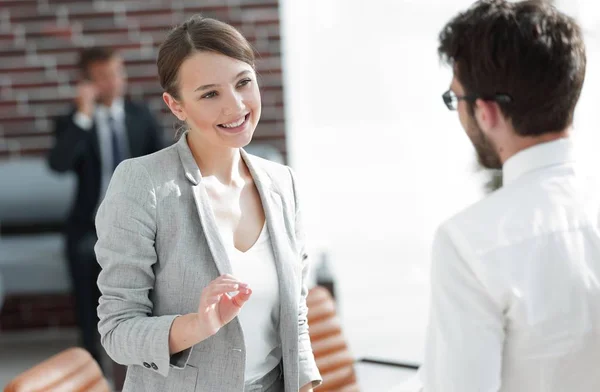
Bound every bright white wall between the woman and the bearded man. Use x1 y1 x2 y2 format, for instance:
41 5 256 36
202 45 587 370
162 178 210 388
281 0 600 361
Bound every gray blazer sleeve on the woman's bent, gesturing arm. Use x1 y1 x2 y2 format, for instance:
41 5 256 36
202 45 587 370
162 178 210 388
95 160 191 377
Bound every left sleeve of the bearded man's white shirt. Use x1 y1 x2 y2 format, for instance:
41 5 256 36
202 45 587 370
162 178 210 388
420 226 505 392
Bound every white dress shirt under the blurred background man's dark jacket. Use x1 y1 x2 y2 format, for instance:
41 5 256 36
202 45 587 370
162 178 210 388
73 98 129 202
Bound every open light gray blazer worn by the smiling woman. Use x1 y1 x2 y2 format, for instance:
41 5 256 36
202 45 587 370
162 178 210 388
95 135 321 392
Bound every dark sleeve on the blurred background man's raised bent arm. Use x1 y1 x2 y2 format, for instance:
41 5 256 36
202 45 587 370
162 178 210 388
48 110 94 172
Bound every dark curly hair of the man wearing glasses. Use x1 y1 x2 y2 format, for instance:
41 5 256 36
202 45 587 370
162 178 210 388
438 0 586 136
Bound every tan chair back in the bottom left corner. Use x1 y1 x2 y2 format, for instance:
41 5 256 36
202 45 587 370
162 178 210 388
4 347 110 392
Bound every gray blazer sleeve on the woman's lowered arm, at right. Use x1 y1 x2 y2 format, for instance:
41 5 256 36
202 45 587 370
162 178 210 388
289 168 323 388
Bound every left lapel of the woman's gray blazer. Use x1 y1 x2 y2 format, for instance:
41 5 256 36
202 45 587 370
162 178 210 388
177 134 232 274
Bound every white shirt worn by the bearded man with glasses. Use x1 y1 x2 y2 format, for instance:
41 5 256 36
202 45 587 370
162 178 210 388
420 139 600 392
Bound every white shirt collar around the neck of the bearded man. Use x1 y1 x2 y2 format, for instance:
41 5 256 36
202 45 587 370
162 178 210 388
502 138 576 184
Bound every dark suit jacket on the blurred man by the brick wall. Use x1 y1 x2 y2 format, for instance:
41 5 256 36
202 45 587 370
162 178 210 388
48 100 163 250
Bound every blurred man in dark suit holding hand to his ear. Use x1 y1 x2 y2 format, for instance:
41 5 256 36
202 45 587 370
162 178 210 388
48 47 163 363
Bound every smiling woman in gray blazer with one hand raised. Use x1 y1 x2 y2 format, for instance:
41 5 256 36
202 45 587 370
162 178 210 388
96 16 321 392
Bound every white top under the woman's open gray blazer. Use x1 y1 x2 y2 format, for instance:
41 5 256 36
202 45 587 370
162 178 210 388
225 223 282 383
